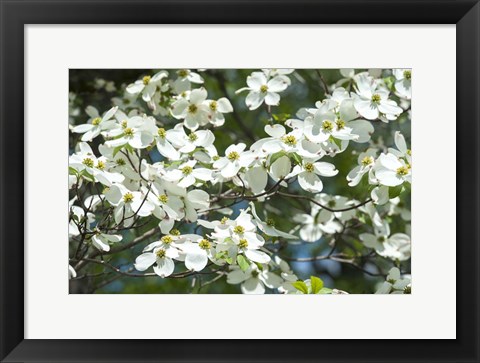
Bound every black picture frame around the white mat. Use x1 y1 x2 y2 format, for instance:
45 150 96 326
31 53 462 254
0 0 480 362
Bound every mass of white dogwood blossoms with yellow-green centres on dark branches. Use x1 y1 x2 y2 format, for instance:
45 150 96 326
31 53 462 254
69 69 412 293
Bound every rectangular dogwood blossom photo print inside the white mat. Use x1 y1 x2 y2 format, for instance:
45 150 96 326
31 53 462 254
68 69 412 294
